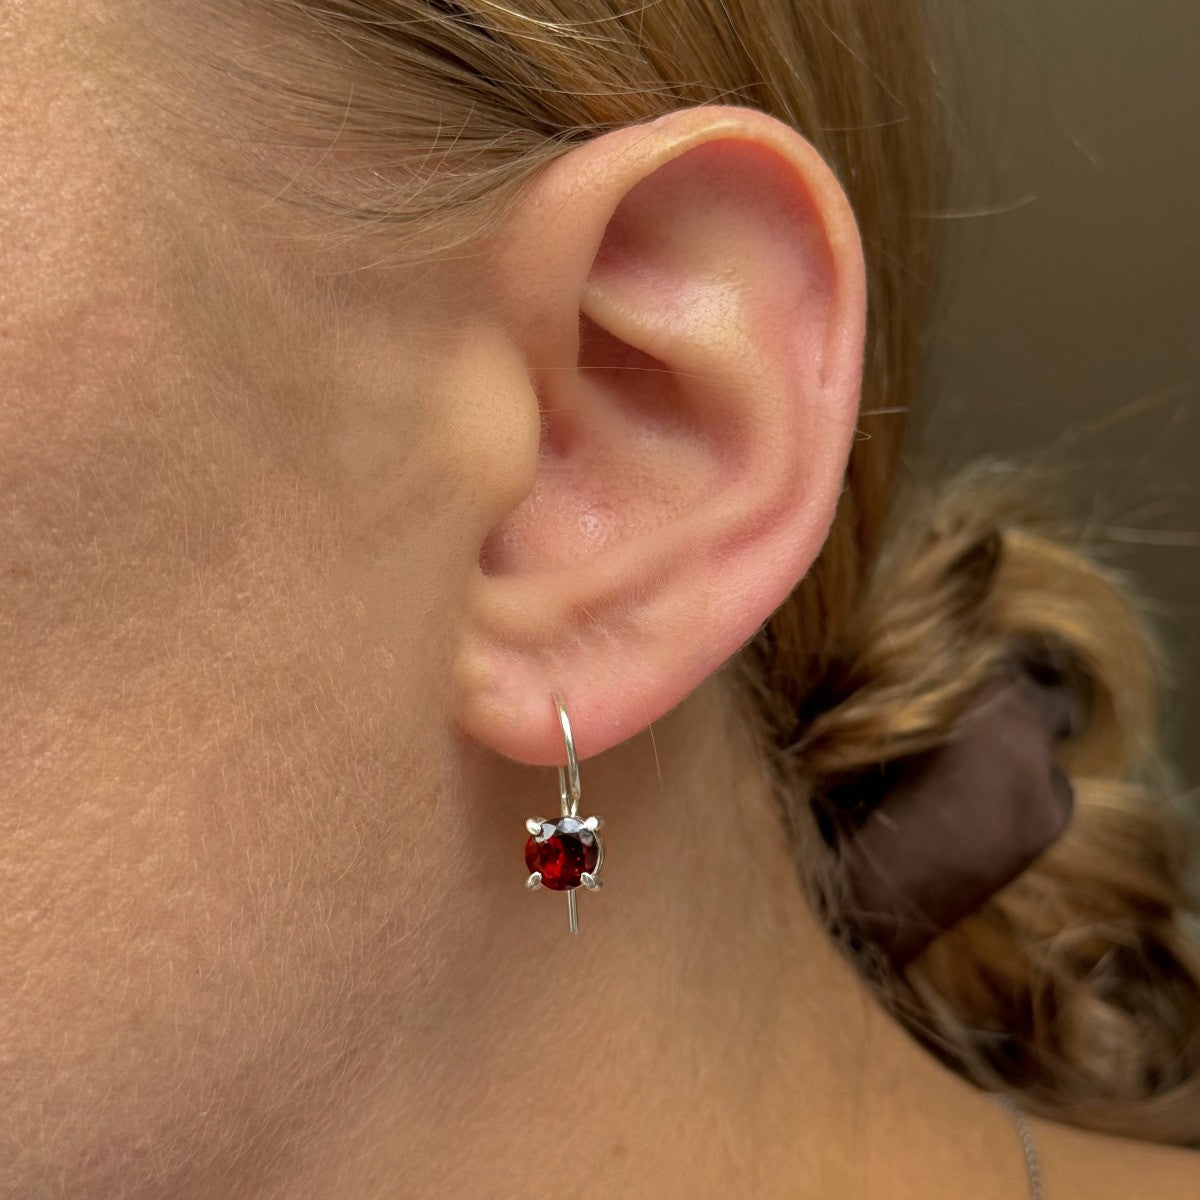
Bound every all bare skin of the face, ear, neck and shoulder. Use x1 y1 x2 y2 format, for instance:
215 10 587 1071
0 4 1190 1200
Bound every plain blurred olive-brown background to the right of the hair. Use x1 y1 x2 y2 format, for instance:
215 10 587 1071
918 0 1200 787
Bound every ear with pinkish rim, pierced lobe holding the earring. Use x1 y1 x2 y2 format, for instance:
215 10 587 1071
455 106 866 764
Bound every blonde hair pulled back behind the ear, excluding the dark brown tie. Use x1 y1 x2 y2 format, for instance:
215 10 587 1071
175 0 1200 1144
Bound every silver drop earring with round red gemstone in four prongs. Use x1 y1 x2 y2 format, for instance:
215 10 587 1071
526 691 604 934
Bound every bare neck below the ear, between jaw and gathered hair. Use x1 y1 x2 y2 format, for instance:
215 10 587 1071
246 688 1025 1200
